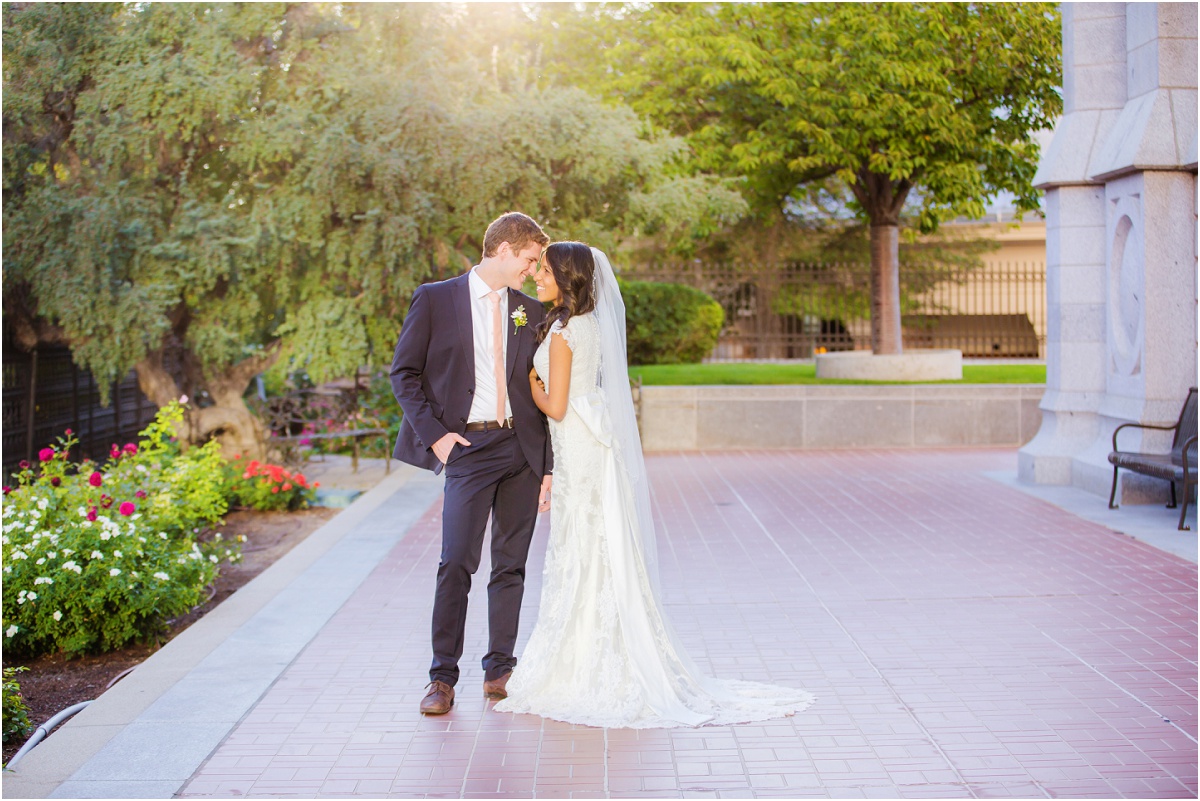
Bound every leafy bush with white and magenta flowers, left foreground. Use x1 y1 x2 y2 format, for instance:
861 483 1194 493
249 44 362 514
2 403 239 656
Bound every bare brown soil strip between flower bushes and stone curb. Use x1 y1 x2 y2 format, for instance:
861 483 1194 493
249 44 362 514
4 507 341 764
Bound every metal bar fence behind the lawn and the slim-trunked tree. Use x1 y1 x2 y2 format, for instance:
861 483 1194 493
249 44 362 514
622 263 1045 360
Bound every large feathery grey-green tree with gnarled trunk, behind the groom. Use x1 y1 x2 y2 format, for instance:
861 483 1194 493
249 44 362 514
4 2 729 453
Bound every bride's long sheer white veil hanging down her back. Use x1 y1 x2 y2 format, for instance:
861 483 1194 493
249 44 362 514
592 248 659 594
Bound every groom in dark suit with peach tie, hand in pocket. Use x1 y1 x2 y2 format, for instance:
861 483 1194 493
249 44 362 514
391 211 553 715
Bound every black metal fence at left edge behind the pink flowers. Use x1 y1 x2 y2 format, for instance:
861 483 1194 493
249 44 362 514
2 336 157 481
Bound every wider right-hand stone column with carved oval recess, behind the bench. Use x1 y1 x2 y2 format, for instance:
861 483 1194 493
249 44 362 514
1072 2 1196 504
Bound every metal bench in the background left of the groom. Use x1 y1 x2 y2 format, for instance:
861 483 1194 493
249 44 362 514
253 390 391 474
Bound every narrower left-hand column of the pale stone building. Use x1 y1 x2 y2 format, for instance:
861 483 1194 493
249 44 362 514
1018 2 1126 484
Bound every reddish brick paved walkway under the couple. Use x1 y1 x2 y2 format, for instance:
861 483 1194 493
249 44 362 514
181 451 1198 797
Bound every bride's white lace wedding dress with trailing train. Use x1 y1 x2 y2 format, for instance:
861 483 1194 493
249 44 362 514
494 308 814 728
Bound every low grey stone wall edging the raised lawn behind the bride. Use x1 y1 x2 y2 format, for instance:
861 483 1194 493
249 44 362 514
641 384 1045 451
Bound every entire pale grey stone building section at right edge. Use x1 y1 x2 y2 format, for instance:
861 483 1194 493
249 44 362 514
1019 2 1196 502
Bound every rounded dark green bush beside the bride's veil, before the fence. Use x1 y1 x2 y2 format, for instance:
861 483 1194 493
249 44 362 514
620 275 725 365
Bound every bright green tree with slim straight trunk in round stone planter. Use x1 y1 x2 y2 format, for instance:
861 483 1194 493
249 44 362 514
611 2 1062 354
